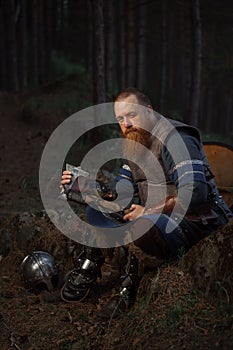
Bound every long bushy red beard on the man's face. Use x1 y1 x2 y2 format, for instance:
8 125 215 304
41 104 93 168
123 127 151 158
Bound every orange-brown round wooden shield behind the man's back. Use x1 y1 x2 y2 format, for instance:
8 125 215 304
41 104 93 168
203 141 233 208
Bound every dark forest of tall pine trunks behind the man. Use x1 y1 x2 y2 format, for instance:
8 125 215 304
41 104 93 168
0 0 233 139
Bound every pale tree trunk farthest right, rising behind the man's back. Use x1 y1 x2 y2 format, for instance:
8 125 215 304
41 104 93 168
191 0 202 126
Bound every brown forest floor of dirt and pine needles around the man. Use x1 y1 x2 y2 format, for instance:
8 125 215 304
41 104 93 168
0 79 233 350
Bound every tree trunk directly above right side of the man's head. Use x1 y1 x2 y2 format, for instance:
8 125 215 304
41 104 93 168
137 0 148 90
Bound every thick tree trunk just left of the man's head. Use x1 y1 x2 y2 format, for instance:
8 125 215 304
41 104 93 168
91 0 106 104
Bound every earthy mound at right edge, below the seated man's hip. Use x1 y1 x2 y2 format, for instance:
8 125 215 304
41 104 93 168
183 219 233 303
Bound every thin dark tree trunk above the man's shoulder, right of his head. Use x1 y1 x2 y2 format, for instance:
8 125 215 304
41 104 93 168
159 0 168 113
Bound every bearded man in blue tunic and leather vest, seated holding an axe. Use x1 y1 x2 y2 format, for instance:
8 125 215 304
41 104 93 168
61 88 232 318
